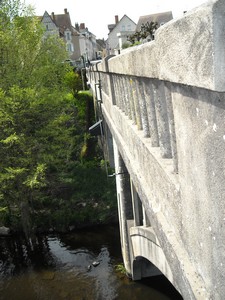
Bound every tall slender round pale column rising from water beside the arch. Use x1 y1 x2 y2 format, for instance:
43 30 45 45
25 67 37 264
113 140 132 276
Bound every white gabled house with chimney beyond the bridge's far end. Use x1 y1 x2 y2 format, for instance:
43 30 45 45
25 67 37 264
106 15 136 55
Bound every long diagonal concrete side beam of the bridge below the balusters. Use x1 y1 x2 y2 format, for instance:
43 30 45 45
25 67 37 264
102 92 210 300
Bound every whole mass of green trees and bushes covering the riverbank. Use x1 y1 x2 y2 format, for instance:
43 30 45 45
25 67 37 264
0 0 117 237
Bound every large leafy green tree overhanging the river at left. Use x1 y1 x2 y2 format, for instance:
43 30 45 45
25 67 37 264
0 0 74 237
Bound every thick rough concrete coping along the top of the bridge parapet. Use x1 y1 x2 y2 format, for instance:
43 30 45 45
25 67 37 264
103 0 225 91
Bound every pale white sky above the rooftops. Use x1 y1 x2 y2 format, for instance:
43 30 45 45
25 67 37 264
25 0 207 39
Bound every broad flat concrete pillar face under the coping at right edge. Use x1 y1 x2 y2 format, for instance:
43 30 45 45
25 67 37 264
173 86 225 299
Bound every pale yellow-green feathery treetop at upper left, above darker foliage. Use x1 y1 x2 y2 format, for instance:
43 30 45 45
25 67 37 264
0 0 69 90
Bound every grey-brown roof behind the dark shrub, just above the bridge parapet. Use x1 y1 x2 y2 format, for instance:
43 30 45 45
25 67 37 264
136 11 173 31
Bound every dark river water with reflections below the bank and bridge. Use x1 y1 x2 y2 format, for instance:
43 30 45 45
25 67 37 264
0 226 182 300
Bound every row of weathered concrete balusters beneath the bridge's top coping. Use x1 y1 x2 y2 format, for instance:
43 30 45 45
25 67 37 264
89 67 178 172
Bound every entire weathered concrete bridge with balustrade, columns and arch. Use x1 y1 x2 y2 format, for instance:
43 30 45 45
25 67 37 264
88 0 225 300
